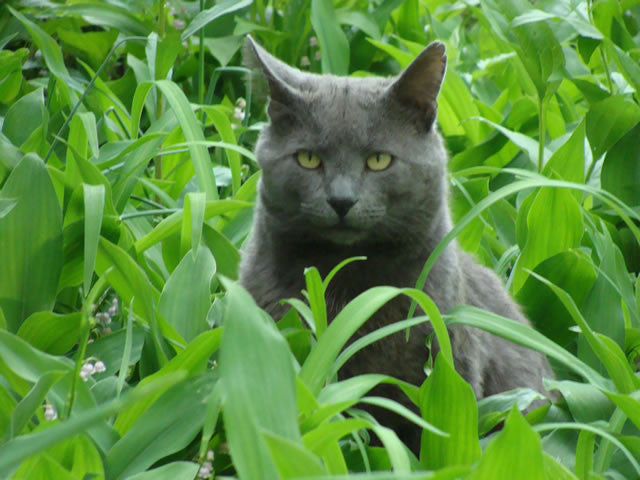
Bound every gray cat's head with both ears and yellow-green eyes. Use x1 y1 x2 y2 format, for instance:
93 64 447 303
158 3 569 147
245 37 448 245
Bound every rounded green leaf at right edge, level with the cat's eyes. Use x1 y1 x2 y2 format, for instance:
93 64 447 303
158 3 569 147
586 95 640 159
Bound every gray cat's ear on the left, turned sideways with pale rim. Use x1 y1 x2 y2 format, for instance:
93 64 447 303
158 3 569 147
243 35 300 120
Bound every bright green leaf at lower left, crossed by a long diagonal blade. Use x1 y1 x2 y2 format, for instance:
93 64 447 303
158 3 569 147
113 328 222 435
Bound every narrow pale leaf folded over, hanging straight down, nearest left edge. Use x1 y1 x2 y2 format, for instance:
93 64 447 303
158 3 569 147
82 184 105 295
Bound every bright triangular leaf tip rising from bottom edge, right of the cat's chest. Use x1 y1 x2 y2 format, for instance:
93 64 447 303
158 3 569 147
469 406 545 480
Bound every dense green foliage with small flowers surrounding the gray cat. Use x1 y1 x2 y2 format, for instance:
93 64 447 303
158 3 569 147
0 0 640 480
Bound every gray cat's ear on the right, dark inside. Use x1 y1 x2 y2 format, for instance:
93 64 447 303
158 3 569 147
389 42 447 129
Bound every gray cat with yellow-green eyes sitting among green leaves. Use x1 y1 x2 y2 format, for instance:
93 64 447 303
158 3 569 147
240 38 552 452
